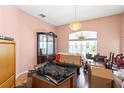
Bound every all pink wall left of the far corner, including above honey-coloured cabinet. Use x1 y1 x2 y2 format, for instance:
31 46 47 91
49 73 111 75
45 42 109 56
0 6 55 74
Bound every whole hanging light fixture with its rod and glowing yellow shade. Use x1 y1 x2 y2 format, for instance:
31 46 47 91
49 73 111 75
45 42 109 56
69 5 81 31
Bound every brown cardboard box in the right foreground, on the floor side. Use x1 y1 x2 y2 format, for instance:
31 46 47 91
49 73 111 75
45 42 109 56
90 67 113 88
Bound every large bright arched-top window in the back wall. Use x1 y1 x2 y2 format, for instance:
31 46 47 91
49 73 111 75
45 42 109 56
69 31 97 56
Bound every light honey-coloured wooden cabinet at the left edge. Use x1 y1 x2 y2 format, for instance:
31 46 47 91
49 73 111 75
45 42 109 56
0 40 15 88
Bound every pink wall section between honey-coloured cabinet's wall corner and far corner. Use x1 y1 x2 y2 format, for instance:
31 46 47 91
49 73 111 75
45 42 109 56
17 8 55 72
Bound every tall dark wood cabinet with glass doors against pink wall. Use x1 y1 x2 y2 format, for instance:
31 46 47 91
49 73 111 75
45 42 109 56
37 32 57 64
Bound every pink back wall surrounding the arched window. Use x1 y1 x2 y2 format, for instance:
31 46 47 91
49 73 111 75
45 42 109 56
56 14 122 55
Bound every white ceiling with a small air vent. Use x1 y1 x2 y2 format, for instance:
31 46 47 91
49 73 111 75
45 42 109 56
17 5 124 26
